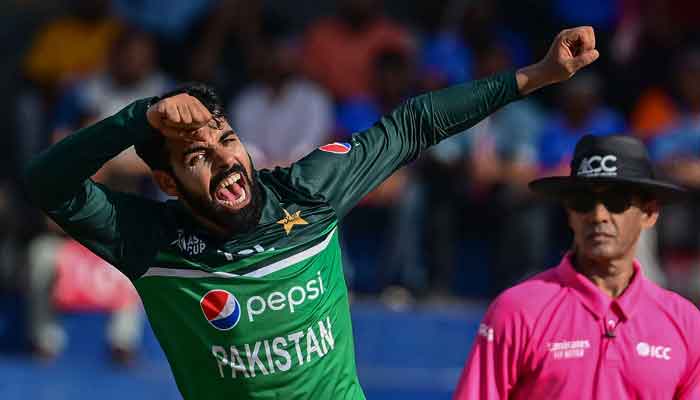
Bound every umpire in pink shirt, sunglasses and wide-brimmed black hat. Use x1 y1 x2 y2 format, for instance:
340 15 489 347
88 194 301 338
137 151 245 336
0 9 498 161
454 135 700 400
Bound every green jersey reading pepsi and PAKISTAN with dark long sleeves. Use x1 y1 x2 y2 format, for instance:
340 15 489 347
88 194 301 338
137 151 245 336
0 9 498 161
25 73 519 400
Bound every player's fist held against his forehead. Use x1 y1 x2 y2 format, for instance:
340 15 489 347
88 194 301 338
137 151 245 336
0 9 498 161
146 93 212 140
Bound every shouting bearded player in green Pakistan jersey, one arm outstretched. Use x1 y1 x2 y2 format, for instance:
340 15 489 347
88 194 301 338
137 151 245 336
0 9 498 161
25 27 598 400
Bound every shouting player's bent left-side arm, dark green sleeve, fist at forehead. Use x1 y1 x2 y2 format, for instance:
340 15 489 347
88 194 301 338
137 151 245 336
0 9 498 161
24 95 211 278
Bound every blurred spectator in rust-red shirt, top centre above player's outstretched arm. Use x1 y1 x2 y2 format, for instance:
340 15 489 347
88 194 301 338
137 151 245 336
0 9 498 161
303 0 413 100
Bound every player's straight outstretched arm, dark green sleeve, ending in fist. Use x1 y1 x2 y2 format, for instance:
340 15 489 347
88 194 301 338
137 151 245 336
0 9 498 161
277 27 598 216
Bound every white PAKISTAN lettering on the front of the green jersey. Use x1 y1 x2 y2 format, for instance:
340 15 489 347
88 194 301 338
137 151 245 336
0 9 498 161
211 317 335 379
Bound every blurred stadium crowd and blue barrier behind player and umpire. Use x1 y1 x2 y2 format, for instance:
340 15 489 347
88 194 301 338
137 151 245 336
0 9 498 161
0 0 700 400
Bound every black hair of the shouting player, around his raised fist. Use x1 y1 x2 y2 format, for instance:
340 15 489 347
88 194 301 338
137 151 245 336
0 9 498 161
134 83 225 172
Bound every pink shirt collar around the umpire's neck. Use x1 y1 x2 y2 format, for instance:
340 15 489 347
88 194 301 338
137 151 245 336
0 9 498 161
556 252 647 320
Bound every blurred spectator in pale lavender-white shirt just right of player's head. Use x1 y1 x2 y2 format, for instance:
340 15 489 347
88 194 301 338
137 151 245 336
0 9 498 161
229 16 333 168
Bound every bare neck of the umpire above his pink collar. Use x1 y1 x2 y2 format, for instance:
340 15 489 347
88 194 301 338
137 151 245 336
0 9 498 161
572 253 634 298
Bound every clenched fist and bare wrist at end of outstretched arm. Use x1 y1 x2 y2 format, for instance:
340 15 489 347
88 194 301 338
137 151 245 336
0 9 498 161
516 26 600 94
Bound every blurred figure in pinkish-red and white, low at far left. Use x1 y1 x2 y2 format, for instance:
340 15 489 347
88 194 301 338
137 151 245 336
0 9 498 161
26 222 143 364
